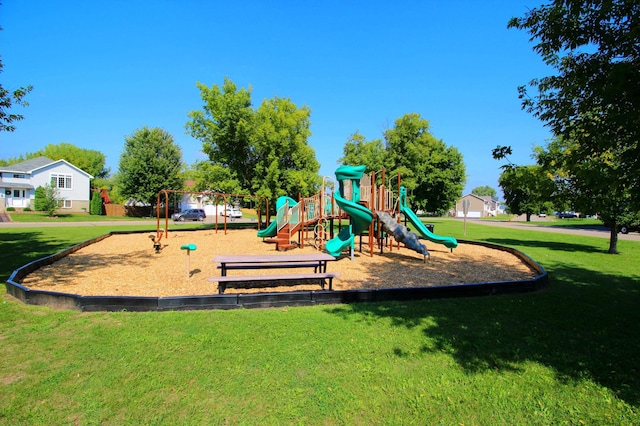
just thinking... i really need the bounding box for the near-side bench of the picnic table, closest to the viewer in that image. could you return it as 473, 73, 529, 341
209, 272, 340, 294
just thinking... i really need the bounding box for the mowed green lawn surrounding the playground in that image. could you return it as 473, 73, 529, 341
0, 219, 640, 425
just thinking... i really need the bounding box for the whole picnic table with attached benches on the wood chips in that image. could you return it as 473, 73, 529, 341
209, 253, 339, 294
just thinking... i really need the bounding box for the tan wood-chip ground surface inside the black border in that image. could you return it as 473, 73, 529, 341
22, 230, 537, 297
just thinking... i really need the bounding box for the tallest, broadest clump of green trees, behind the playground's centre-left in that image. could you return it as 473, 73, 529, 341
186, 79, 320, 208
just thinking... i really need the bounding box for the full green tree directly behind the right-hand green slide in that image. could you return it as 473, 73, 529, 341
384, 113, 466, 212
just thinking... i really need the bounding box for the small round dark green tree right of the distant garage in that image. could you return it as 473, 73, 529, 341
498, 165, 554, 222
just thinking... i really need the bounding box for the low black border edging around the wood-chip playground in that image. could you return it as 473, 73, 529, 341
6, 230, 549, 312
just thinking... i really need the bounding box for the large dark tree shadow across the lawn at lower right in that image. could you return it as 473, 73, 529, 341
329, 265, 640, 405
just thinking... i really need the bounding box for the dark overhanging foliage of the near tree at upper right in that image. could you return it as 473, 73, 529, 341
509, 0, 640, 210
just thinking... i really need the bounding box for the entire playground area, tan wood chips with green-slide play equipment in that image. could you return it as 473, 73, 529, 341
15, 166, 537, 297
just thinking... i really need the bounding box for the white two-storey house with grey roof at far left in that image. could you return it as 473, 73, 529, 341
0, 157, 93, 213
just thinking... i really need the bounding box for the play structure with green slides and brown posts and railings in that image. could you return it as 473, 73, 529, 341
258, 165, 458, 260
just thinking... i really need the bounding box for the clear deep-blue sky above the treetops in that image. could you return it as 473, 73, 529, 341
0, 0, 551, 193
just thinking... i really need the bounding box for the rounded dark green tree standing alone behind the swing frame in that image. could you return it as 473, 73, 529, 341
118, 127, 183, 206
